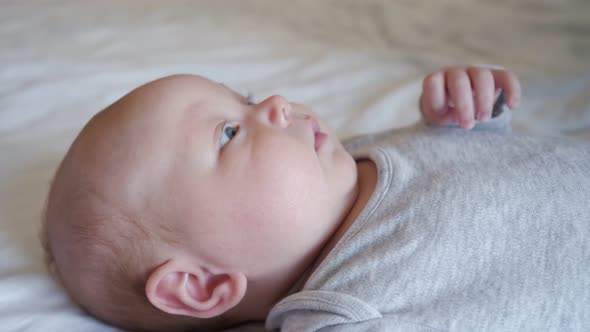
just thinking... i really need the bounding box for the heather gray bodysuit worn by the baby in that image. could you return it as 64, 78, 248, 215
266, 111, 590, 331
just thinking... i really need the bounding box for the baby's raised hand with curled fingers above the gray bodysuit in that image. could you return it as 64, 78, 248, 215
420, 67, 520, 129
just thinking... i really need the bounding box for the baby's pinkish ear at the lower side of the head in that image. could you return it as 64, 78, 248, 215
145, 260, 247, 318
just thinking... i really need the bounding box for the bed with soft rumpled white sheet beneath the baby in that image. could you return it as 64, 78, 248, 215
0, 0, 590, 332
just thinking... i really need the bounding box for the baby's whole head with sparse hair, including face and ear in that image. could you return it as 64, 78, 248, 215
43, 75, 357, 331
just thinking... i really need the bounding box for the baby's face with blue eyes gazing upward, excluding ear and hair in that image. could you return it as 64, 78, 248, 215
126, 76, 357, 275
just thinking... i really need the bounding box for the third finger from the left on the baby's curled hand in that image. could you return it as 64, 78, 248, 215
467, 67, 495, 122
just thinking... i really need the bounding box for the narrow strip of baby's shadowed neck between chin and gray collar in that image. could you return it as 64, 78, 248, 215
299, 159, 378, 288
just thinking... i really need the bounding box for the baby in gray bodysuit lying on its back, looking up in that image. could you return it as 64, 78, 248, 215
43, 67, 590, 331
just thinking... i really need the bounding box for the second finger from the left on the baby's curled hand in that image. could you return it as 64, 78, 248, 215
445, 68, 474, 129
